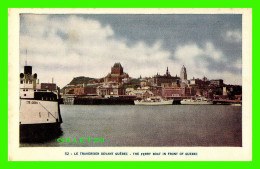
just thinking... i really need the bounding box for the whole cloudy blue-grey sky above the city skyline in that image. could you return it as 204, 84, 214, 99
19, 14, 242, 87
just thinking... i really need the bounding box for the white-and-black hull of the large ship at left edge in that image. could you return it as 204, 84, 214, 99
20, 99, 62, 142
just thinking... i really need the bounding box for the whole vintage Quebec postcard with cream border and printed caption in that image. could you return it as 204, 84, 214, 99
8, 8, 252, 161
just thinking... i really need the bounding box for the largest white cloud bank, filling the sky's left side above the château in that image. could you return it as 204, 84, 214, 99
20, 15, 171, 86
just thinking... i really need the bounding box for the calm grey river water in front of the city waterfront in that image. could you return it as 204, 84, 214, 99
20, 105, 242, 147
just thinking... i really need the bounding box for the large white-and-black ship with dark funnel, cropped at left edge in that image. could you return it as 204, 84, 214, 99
19, 65, 62, 142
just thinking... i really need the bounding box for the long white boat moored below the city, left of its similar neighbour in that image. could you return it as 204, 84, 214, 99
134, 97, 173, 105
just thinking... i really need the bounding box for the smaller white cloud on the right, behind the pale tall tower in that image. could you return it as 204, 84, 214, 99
173, 42, 242, 84
